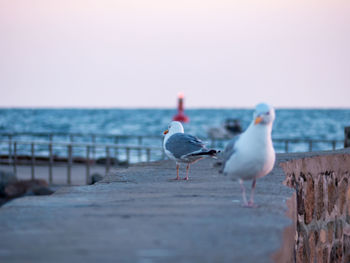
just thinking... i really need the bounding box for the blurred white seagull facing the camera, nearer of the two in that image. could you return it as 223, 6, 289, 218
222, 103, 276, 207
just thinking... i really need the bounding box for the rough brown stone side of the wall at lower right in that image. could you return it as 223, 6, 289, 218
281, 154, 350, 263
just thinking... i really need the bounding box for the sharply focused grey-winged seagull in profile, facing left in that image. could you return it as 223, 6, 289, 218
163, 121, 218, 180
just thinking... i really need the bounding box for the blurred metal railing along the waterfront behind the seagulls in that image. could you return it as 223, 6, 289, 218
0, 133, 344, 184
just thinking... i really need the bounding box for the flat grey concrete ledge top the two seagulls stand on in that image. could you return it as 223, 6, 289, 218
0, 150, 348, 262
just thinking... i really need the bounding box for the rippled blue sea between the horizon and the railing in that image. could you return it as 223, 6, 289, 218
0, 109, 350, 160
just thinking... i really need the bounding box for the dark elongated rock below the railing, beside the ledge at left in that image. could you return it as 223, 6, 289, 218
4, 179, 52, 199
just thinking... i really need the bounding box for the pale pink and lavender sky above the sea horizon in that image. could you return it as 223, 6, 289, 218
0, 0, 350, 108
